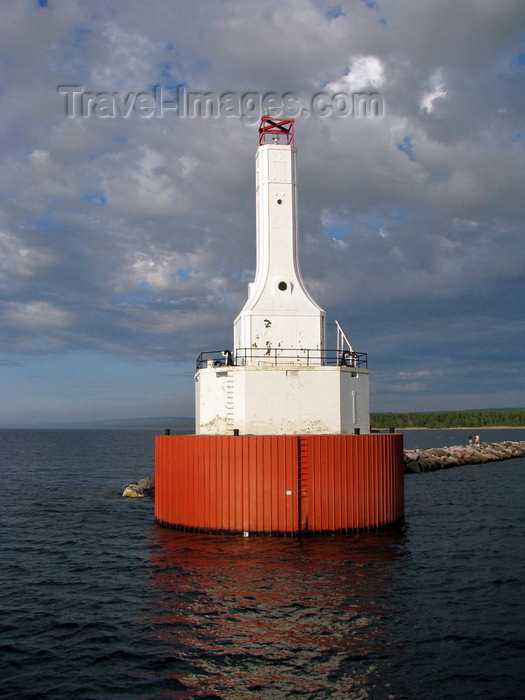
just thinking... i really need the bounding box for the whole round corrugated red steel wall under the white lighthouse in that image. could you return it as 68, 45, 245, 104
155, 435, 404, 535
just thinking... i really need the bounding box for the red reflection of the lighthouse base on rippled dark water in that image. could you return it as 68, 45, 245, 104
145, 528, 403, 698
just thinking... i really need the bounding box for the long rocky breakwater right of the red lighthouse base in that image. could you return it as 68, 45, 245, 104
404, 440, 525, 474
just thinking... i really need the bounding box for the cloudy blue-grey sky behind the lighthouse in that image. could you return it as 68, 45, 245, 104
0, 0, 525, 427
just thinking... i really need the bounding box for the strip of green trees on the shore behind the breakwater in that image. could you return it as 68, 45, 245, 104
370, 409, 525, 429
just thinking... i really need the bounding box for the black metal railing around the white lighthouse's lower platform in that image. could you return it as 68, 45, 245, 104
196, 348, 368, 370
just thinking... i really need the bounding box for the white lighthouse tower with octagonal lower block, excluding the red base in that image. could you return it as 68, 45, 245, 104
195, 117, 370, 435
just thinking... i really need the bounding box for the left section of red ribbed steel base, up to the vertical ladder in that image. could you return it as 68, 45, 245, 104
155, 435, 298, 534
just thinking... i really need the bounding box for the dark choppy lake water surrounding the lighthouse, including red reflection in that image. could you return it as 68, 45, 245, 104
0, 430, 525, 698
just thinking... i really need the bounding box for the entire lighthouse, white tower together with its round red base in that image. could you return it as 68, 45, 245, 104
155, 116, 404, 536
